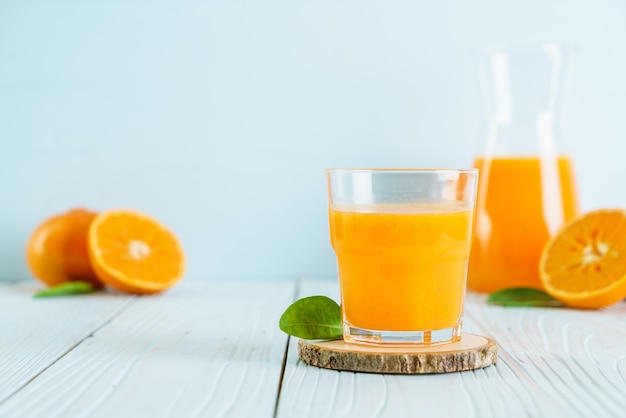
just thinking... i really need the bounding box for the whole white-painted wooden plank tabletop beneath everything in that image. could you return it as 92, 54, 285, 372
0, 280, 626, 418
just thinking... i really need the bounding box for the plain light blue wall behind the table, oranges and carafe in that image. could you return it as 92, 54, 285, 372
0, 0, 626, 280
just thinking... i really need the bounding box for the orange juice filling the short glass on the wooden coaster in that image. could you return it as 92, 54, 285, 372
329, 202, 472, 331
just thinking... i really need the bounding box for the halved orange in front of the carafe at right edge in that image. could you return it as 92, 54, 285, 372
539, 209, 626, 309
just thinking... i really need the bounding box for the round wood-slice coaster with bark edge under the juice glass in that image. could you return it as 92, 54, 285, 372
298, 334, 498, 374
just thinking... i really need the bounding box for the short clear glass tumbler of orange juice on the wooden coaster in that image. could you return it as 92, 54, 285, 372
326, 169, 478, 346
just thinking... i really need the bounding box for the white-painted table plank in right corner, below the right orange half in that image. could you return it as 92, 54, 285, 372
460, 295, 626, 417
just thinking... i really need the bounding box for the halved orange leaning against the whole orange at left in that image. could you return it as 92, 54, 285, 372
89, 209, 185, 294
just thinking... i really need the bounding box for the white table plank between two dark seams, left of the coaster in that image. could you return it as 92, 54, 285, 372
0, 281, 294, 418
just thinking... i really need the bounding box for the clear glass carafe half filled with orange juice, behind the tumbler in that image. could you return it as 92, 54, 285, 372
468, 45, 578, 292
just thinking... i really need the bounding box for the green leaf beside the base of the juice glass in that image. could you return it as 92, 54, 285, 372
278, 296, 343, 340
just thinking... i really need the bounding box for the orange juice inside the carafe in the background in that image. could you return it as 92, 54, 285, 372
467, 156, 578, 292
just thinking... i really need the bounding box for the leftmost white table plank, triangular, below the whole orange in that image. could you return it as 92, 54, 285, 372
0, 281, 132, 404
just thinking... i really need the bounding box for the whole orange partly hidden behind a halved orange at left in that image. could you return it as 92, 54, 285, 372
26, 209, 102, 286
